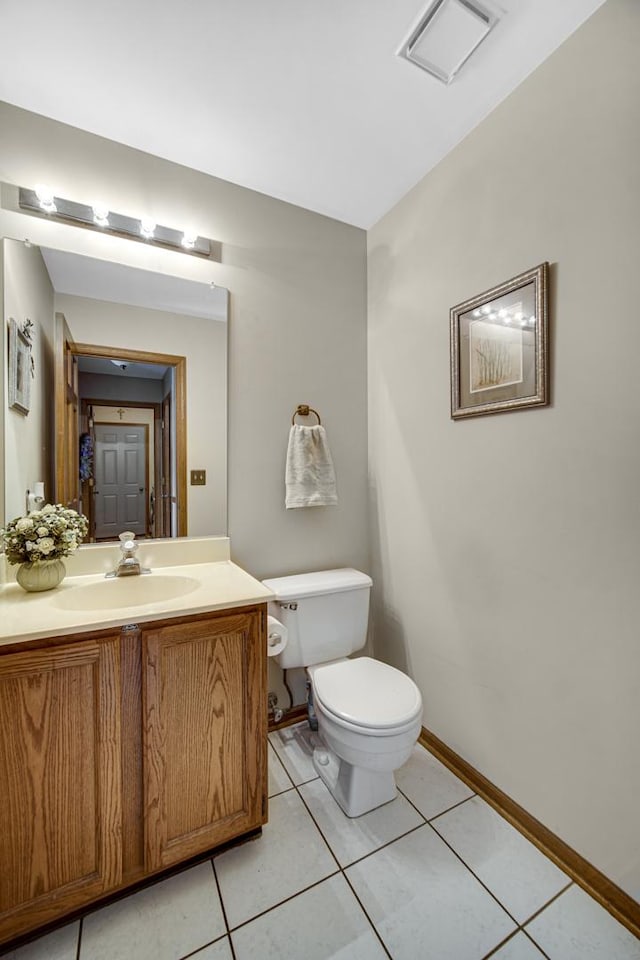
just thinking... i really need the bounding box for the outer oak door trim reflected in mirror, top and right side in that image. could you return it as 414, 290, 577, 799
70, 342, 187, 537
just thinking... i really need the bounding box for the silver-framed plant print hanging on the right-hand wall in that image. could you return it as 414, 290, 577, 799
450, 263, 549, 420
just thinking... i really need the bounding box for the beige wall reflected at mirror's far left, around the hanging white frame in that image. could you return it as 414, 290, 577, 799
0, 240, 53, 520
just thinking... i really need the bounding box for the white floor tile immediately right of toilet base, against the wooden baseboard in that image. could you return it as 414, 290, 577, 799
396, 744, 473, 820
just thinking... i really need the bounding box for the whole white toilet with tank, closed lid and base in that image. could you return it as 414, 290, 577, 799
263, 568, 422, 817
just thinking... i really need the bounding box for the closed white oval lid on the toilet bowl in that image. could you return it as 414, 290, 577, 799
313, 657, 422, 728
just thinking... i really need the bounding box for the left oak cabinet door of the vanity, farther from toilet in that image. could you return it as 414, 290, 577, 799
0, 638, 121, 940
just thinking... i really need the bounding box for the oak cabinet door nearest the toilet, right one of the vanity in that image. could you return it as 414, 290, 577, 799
143, 609, 266, 870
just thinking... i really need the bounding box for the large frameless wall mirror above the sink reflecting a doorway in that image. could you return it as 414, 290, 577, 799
3, 238, 228, 539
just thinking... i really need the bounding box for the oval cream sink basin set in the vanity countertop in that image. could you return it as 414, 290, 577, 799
52, 573, 200, 611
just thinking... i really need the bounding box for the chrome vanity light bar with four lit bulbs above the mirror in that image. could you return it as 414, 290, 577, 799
18, 185, 222, 262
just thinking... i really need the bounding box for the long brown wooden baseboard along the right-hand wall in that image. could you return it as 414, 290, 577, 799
419, 727, 640, 937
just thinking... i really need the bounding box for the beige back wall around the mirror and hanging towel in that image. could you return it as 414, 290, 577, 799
0, 104, 368, 577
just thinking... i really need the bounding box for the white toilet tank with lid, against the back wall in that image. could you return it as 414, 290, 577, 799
263, 568, 372, 670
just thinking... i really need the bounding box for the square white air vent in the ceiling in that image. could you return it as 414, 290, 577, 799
398, 0, 499, 83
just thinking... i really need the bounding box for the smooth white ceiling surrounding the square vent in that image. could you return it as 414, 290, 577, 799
0, 0, 603, 228
